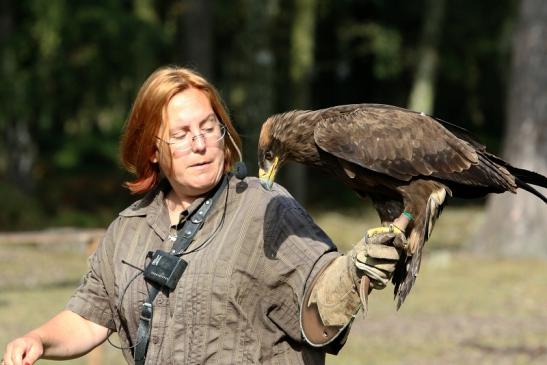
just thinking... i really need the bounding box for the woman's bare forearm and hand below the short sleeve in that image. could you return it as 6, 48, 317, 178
3, 310, 108, 365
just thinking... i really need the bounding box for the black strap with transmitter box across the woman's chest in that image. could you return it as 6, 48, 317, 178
133, 176, 228, 365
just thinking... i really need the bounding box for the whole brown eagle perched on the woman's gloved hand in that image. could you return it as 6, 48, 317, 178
258, 104, 547, 309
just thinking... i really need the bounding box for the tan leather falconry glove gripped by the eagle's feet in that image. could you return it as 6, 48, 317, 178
301, 230, 401, 346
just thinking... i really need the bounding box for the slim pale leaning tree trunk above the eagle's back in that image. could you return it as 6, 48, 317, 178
408, 0, 445, 114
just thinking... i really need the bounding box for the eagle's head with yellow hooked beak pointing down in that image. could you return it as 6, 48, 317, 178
258, 115, 287, 190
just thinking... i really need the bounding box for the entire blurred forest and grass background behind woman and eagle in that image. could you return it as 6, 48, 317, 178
0, 0, 547, 365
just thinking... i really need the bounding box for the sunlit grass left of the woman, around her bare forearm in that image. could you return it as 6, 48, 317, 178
0, 245, 125, 365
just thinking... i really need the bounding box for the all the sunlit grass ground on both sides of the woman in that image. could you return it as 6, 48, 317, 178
0, 207, 547, 365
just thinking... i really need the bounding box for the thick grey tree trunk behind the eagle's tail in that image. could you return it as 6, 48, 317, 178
474, 0, 547, 257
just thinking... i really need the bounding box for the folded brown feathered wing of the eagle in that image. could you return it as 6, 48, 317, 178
314, 104, 479, 181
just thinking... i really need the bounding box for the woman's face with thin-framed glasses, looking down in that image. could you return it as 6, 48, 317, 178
154, 88, 224, 199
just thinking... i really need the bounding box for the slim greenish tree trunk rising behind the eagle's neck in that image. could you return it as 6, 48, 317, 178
286, 0, 316, 205
